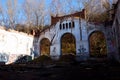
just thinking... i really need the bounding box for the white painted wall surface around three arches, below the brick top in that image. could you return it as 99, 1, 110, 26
37, 18, 112, 60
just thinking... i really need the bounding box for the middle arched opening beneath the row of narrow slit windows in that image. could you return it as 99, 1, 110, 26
61, 33, 76, 55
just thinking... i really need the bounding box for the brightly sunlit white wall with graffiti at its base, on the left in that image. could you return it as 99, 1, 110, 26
0, 28, 33, 64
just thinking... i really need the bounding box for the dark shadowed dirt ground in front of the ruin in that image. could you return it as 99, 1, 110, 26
0, 61, 120, 80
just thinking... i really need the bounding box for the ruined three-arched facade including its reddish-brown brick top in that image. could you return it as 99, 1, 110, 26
34, 10, 115, 60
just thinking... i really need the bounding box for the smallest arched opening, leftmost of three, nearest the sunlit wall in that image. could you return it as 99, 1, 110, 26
40, 38, 50, 56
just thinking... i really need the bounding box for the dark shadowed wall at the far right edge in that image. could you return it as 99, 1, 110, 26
112, 0, 120, 59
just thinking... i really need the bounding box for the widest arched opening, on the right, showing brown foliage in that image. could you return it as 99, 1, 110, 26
89, 31, 107, 58
